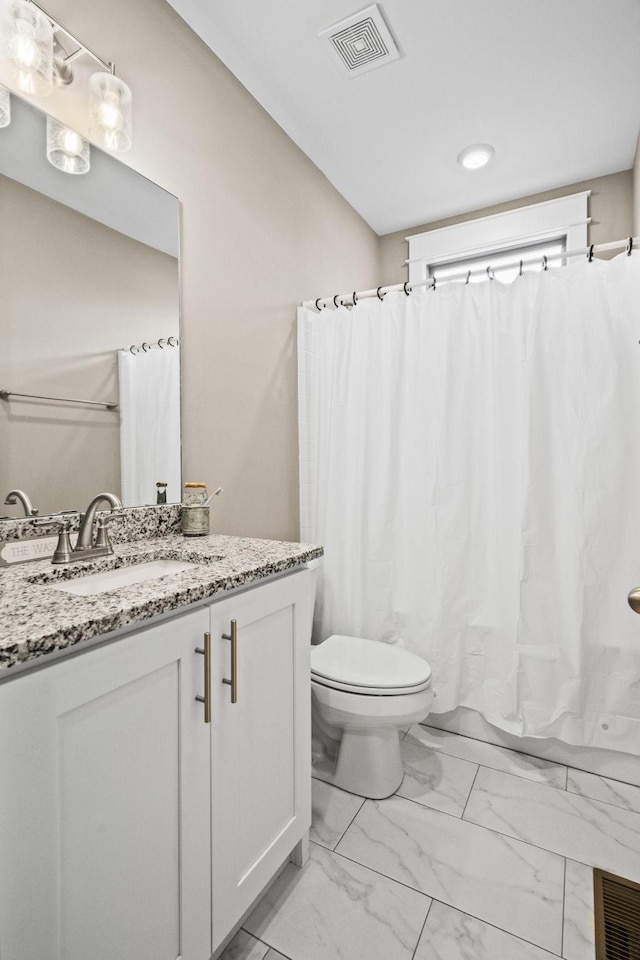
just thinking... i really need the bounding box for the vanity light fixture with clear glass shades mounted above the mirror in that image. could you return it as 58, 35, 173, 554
0, 0, 132, 152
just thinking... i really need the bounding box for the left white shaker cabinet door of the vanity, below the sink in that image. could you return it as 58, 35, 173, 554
0, 608, 211, 960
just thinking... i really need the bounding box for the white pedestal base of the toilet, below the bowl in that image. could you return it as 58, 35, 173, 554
313, 727, 404, 800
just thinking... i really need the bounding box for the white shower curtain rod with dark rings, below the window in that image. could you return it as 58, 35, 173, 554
302, 237, 640, 310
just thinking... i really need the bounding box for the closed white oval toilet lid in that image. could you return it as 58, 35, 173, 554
311, 634, 431, 694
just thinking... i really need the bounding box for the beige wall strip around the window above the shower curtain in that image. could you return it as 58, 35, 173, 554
380, 170, 640, 284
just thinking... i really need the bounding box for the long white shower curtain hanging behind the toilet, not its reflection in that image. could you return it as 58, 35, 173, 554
298, 255, 640, 753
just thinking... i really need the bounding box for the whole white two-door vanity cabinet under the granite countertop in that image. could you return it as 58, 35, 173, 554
0, 569, 313, 960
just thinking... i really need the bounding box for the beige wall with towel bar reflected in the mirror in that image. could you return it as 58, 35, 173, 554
0, 177, 179, 516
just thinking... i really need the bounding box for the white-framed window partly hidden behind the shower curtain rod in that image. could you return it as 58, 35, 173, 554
407, 191, 589, 283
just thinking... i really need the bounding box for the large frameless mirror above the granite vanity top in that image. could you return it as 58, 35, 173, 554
0, 94, 180, 518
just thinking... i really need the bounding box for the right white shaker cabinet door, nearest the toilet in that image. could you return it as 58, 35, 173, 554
211, 570, 313, 950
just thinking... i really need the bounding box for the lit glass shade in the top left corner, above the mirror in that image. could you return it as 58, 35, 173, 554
2, 0, 53, 97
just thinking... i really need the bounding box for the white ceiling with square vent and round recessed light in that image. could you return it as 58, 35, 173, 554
164, 0, 640, 234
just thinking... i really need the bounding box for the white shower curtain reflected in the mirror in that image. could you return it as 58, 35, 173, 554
118, 347, 181, 507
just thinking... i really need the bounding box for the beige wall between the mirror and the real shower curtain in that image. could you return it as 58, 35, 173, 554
32, 0, 379, 539
